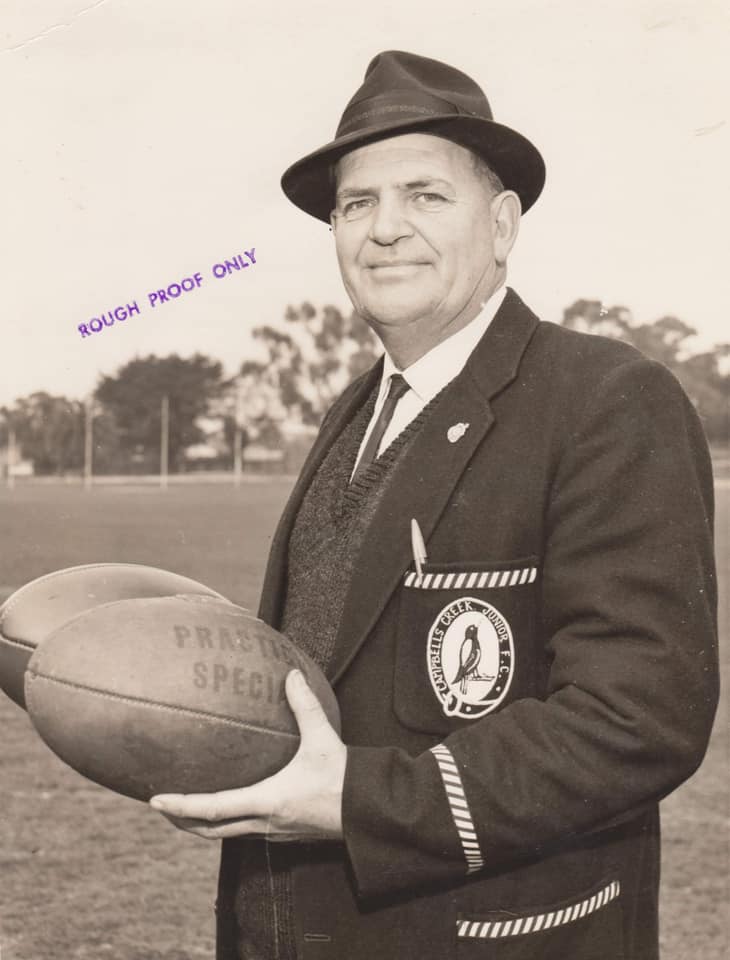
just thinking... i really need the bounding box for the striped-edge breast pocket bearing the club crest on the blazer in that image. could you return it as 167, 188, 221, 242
393, 557, 539, 736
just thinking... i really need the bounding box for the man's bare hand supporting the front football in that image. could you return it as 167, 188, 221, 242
150, 670, 347, 841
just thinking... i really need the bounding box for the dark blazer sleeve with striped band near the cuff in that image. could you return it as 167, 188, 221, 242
343, 359, 718, 897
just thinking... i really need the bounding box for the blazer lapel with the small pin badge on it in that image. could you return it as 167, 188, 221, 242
327, 290, 538, 683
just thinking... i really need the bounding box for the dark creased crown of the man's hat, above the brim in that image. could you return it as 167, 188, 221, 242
335, 50, 493, 137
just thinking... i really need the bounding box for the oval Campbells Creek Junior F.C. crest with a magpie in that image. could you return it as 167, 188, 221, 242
427, 597, 515, 720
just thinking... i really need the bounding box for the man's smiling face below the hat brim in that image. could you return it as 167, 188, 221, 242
333, 133, 503, 349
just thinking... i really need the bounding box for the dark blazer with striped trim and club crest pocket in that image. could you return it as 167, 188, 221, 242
220, 290, 717, 960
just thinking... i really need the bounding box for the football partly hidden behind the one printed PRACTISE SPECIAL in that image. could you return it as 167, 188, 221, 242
0, 563, 223, 707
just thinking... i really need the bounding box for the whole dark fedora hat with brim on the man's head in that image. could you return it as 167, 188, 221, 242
281, 50, 545, 223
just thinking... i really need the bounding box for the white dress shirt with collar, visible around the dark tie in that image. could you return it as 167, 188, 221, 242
352, 286, 507, 476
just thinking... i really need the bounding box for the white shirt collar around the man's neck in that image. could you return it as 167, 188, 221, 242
380, 286, 507, 404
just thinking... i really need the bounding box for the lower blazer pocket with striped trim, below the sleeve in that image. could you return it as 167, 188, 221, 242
456, 880, 624, 960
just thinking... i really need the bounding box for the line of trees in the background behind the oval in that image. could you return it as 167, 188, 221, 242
0, 300, 730, 475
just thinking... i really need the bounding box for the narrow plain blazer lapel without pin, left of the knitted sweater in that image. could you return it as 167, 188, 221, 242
258, 359, 383, 627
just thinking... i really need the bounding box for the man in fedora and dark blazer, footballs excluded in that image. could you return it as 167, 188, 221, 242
153, 52, 717, 960
